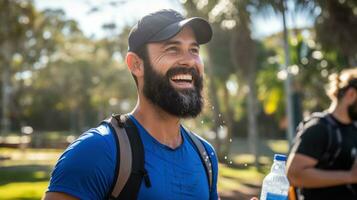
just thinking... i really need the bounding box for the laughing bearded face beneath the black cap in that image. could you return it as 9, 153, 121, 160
143, 28, 203, 117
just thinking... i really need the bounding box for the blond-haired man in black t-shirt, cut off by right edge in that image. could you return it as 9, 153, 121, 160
287, 68, 357, 200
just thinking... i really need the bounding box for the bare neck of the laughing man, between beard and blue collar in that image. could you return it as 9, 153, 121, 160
132, 99, 182, 149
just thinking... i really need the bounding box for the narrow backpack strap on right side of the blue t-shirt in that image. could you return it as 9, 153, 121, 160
182, 126, 213, 192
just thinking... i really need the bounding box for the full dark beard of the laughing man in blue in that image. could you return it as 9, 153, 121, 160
143, 59, 203, 118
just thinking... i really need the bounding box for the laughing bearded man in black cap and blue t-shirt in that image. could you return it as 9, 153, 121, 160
45, 10, 218, 200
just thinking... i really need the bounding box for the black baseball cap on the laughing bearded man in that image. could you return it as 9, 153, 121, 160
128, 9, 212, 52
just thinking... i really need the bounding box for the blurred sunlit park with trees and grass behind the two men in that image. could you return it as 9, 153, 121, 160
0, 0, 357, 199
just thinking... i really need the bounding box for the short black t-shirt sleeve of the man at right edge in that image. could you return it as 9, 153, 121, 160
292, 123, 328, 160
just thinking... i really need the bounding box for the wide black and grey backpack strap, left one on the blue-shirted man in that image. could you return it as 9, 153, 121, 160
103, 115, 151, 200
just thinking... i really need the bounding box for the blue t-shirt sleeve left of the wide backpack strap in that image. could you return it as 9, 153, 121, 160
48, 126, 116, 199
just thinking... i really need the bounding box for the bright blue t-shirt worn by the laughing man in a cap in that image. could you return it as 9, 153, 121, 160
48, 116, 218, 200
